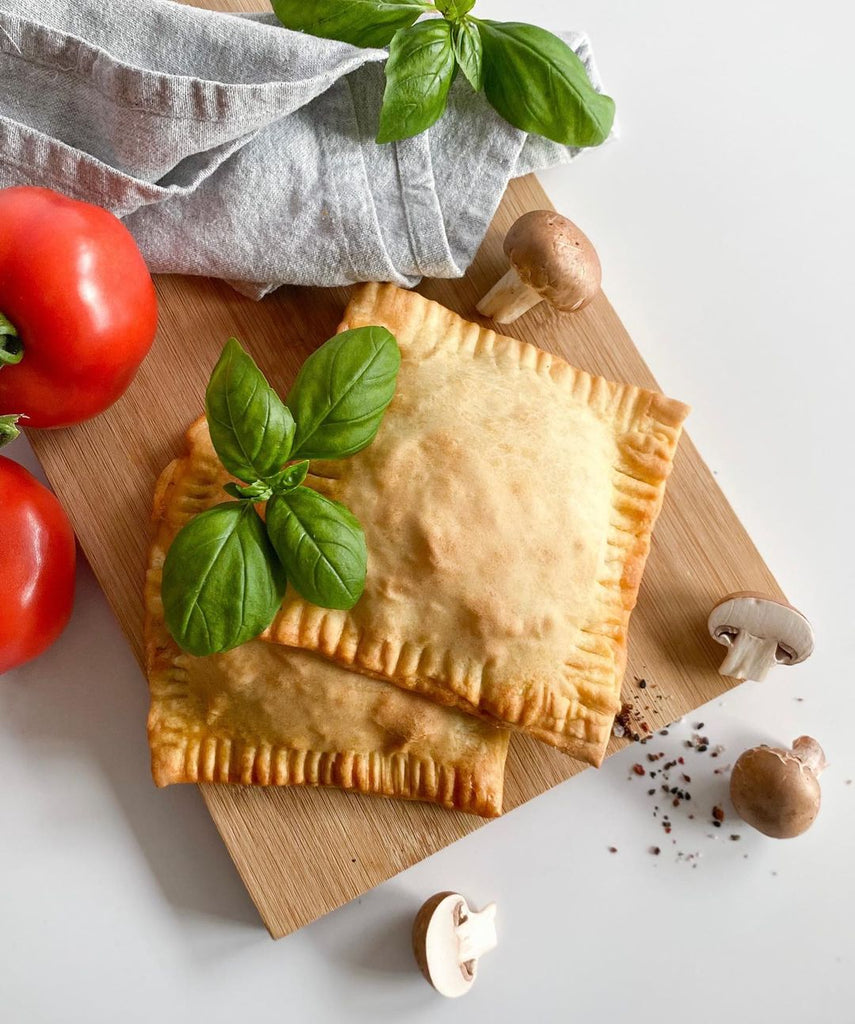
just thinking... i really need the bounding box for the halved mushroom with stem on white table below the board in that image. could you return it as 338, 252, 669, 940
413, 893, 498, 998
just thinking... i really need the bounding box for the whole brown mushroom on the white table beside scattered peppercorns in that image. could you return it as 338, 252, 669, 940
730, 736, 826, 839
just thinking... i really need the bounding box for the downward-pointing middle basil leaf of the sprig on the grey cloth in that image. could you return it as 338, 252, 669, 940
377, 18, 456, 142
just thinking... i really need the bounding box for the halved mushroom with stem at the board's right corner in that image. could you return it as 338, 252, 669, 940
708, 591, 813, 680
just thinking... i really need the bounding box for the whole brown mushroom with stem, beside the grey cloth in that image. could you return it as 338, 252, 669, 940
477, 210, 602, 324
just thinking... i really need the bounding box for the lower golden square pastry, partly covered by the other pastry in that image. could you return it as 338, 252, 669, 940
145, 420, 508, 816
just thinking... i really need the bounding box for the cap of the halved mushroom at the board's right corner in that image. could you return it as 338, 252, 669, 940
708, 590, 814, 665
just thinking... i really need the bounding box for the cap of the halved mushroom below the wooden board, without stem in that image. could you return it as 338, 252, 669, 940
413, 892, 477, 998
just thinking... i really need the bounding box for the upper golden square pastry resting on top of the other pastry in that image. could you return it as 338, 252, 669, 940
267, 285, 688, 765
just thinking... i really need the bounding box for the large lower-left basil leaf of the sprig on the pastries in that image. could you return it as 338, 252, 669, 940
161, 502, 286, 656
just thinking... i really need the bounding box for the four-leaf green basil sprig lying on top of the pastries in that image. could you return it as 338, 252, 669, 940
162, 327, 400, 656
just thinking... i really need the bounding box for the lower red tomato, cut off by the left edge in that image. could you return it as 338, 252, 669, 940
0, 456, 75, 672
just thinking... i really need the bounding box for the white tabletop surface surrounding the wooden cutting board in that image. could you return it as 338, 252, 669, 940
0, 0, 855, 1024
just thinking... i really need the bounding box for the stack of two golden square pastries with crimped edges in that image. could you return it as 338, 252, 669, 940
146, 285, 687, 816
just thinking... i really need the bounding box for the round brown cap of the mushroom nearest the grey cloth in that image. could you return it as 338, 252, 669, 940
504, 210, 602, 312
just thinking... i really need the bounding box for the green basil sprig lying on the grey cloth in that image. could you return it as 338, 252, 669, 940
272, 0, 614, 146
